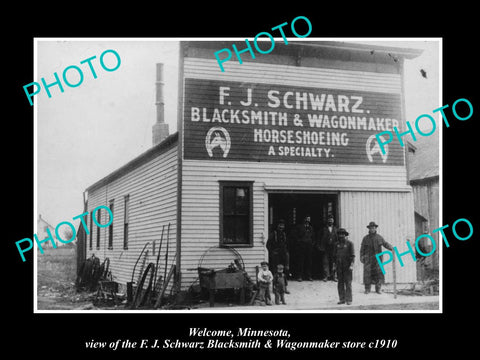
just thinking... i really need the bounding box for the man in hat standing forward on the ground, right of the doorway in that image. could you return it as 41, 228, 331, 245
333, 228, 355, 305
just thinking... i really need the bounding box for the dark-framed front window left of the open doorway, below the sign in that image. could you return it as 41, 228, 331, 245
220, 181, 253, 246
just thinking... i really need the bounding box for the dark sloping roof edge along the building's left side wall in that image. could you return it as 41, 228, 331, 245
86, 132, 178, 192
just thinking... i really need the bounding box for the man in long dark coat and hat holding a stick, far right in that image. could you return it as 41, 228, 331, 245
360, 221, 393, 294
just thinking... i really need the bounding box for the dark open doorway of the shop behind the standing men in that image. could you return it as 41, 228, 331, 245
268, 192, 339, 279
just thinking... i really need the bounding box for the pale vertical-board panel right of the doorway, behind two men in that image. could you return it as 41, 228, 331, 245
339, 191, 416, 283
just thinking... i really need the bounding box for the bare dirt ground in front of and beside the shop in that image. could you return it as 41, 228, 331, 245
37, 246, 439, 311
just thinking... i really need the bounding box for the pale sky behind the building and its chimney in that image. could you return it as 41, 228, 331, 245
35, 38, 442, 229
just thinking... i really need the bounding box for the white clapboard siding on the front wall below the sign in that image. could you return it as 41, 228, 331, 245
181, 160, 413, 286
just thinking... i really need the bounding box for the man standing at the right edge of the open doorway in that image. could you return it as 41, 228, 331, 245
317, 215, 337, 281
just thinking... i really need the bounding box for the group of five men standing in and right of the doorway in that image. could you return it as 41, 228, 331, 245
266, 215, 393, 304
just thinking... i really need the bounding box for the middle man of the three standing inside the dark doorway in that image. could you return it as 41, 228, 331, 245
296, 216, 315, 281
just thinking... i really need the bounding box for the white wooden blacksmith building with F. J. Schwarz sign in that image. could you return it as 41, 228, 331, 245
79, 41, 419, 296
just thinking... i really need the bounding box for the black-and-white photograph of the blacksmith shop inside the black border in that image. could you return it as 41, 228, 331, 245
31, 38, 442, 312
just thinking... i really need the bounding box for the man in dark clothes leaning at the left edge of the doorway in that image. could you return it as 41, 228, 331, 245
266, 220, 290, 294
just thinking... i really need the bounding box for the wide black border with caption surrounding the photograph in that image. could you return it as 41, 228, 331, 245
6, 2, 480, 359
